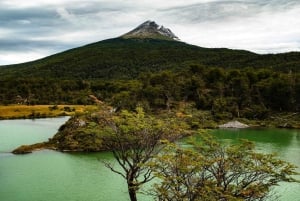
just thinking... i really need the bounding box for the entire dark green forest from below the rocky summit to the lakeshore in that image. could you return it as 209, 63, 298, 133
0, 38, 300, 119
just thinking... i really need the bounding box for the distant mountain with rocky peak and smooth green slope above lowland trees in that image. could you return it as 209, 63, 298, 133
0, 21, 300, 79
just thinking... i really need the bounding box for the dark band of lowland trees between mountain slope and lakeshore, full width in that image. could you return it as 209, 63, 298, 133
0, 64, 300, 119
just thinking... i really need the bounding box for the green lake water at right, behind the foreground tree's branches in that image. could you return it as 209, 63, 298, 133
212, 129, 300, 201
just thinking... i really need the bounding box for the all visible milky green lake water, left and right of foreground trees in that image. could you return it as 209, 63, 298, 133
0, 118, 300, 201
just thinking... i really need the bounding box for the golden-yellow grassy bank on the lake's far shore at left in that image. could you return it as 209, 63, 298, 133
0, 105, 97, 119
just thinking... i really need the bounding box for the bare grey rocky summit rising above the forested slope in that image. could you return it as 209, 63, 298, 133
121, 20, 179, 40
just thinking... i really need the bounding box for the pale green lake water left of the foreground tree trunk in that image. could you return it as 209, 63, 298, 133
0, 118, 136, 201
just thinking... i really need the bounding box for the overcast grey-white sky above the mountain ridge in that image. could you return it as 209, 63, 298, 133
0, 0, 300, 65
